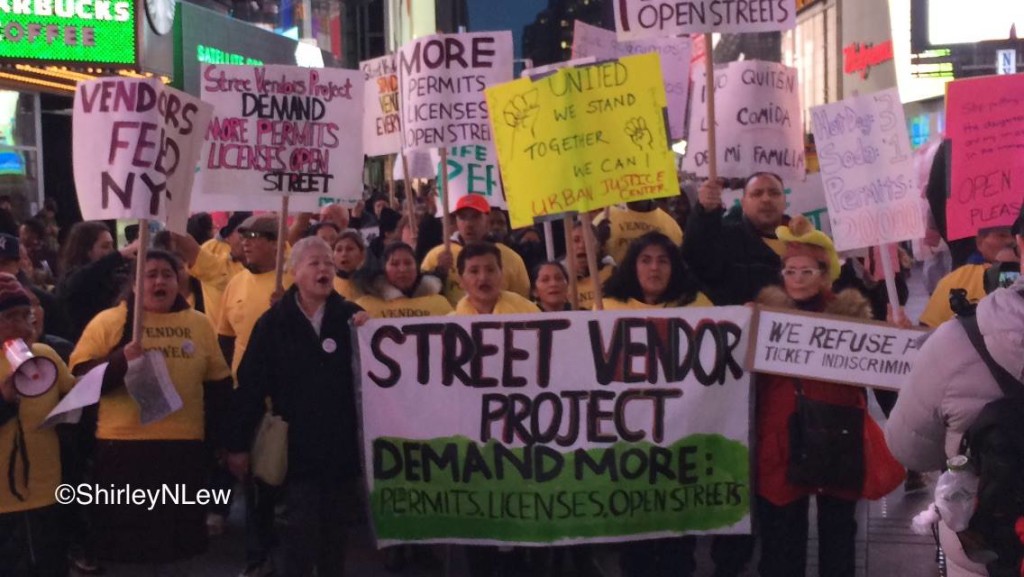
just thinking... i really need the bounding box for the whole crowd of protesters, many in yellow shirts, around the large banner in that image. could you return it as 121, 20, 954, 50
0, 168, 1024, 577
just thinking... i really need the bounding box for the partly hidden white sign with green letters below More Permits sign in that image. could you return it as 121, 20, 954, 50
430, 145, 508, 210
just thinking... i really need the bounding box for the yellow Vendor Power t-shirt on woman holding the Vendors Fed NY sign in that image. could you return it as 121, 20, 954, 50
71, 303, 231, 441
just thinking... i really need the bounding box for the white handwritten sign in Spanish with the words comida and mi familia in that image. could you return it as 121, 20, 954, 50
683, 60, 807, 181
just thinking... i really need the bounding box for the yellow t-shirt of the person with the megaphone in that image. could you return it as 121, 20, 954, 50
0, 346, 75, 514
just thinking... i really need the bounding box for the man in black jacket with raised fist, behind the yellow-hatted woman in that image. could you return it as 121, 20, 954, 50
683, 172, 788, 307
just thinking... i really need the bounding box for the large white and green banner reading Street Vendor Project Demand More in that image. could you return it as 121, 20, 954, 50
358, 306, 753, 546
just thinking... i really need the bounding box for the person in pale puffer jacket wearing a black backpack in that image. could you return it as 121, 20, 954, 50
886, 214, 1024, 577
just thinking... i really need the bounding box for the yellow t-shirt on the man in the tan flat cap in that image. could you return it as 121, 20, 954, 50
217, 271, 292, 374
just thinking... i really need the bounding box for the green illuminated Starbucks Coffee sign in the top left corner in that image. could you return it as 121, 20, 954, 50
0, 0, 135, 65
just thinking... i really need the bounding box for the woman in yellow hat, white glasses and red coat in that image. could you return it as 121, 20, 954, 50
754, 216, 903, 577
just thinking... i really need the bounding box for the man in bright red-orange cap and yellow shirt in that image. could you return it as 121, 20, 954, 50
420, 195, 529, 306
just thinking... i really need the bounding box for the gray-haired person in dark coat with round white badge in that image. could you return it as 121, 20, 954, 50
227, 237, 366, 576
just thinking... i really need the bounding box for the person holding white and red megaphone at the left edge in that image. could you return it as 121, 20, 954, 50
0, 273, 75, 575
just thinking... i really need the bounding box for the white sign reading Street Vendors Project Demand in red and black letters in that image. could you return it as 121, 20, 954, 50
197, 65, 364, 204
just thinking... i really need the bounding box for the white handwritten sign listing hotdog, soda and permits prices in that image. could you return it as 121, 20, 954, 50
811, 88, 925, 250
